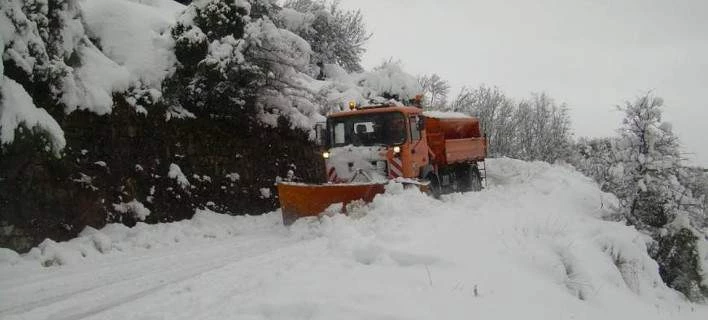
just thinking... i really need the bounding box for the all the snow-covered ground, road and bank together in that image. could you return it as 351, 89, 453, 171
0, 159, 708, 320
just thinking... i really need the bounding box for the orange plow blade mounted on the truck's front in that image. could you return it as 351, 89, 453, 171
278, 182, 386, 225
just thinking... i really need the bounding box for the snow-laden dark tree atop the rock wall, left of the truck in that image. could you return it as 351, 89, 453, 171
168, 0, 320, 130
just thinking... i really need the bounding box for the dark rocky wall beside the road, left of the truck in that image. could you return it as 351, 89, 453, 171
0, 97, 324, 251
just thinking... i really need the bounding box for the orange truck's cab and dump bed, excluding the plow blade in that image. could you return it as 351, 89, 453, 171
323, 106, 487, 191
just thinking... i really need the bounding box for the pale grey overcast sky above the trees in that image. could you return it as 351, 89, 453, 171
342, 0, 708, 166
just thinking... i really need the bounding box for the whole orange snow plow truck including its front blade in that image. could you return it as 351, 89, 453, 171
277, 103, 487, 225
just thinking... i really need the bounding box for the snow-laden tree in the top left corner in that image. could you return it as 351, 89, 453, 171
0, 0, 83, 154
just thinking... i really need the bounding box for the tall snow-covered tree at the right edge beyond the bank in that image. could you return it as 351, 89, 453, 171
610, 94, 708, 300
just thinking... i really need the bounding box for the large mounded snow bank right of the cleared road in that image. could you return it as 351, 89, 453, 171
265, 159, 705, 319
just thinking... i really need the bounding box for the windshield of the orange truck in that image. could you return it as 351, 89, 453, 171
327, 112, 406, 147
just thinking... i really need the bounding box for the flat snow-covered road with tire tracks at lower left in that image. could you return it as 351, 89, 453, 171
0, 238, 294, 320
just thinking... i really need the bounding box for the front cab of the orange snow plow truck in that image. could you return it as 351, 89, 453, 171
323, 106, 430, 183
